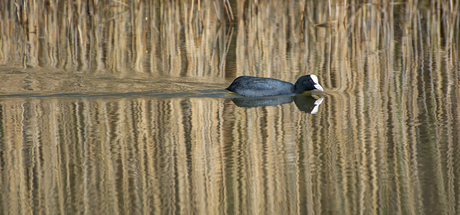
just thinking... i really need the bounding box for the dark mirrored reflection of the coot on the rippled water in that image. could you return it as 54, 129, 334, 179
232, 95, 323, 114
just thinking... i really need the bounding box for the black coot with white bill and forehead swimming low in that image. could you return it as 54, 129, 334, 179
227, 75, 323, 97
